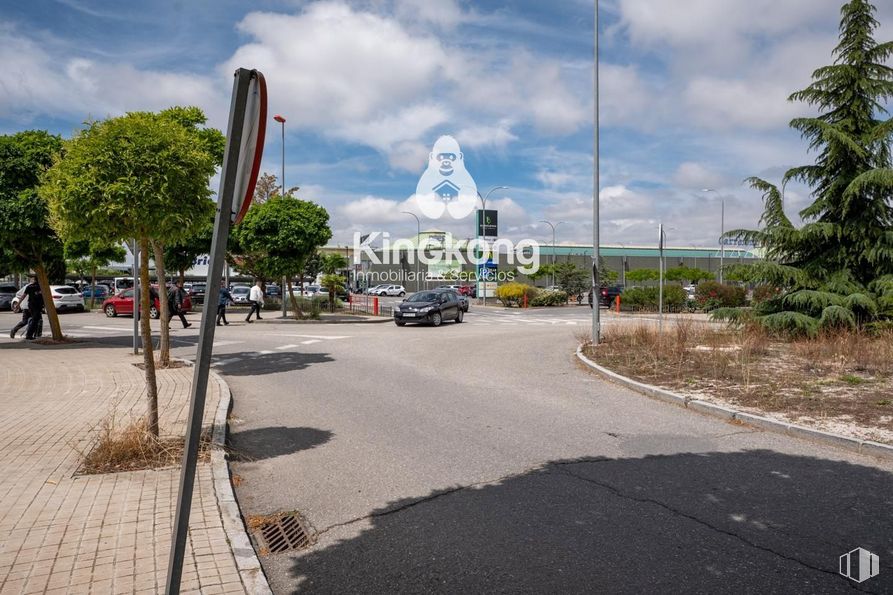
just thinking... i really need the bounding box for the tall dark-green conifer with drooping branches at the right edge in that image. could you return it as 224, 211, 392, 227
715, 0, 893, 334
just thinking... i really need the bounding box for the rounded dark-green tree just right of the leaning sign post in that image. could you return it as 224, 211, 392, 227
233, 195, 332, 317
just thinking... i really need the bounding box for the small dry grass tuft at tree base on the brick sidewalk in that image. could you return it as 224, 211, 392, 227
78, 411, 210, 475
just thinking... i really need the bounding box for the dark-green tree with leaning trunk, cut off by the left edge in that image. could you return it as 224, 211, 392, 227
0, 130, 65, 341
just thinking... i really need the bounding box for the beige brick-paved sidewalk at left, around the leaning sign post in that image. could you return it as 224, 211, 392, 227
0, 341, 266, 595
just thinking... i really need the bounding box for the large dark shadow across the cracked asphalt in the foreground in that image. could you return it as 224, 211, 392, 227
284, 450, 893, 593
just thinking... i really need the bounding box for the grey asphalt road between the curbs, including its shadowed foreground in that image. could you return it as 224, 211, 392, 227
0, 306, 893, 593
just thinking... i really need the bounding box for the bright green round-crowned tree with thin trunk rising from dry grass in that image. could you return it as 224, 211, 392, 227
40, 112, 214, 437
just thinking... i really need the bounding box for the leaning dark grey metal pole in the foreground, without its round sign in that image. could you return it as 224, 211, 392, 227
165, 68, 252, 595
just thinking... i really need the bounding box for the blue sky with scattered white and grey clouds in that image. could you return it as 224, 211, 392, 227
0, 0, 893, 246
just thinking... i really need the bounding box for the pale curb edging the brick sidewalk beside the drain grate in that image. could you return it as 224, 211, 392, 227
210, 370, 273, 595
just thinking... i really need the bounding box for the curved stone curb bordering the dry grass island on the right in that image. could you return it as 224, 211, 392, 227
577, 345, 893, 460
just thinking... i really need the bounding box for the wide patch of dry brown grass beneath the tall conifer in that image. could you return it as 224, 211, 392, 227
586, 320, 893, 442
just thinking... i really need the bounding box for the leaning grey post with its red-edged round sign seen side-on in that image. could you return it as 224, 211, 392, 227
166, 68, 267, 595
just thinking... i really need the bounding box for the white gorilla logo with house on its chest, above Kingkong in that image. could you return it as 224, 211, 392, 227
415, 136, 477, 219
